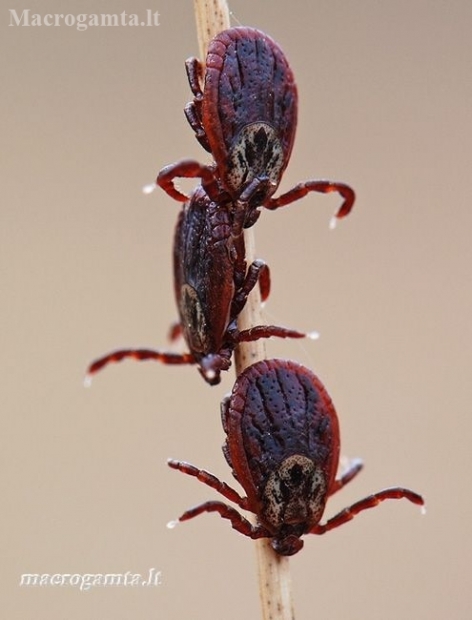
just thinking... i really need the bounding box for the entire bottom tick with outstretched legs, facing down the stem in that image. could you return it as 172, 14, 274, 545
169, 359, 424, 555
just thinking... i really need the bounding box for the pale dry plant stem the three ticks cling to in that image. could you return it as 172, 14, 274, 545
194, 0, 295, 620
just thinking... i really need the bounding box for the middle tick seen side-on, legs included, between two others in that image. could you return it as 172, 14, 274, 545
88, 186, 307, 385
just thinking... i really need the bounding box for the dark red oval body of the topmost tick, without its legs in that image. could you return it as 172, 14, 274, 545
195, 28, 298, 200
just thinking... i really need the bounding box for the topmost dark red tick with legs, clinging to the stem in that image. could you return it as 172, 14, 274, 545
157, 27, 355, 232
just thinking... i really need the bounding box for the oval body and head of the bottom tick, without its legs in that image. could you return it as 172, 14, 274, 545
222, 360, 340, 551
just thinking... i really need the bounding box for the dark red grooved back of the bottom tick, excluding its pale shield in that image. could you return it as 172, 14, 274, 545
224, 360, 339, 512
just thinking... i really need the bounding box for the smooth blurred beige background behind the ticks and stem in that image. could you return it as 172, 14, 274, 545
0, 0, 472, 620
